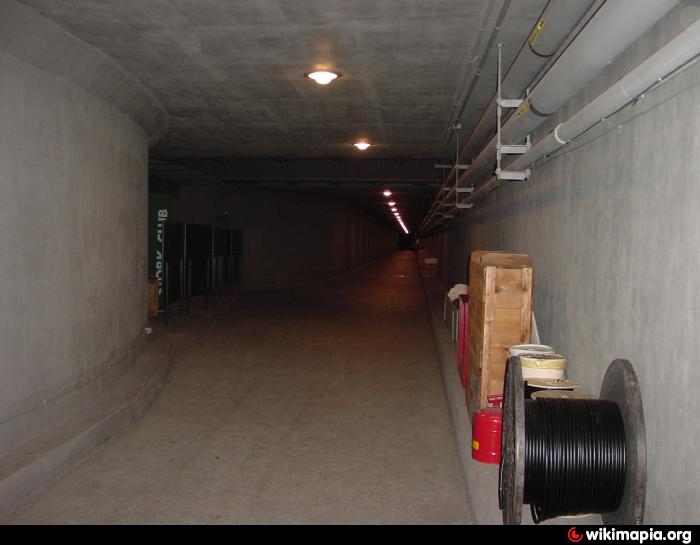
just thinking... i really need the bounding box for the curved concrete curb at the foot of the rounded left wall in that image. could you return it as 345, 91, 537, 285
0, 340, 170, 519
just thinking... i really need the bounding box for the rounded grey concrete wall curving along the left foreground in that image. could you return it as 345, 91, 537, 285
0, 1, 163, 450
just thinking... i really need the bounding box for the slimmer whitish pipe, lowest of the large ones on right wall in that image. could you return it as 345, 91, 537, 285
464, 16, 700, 208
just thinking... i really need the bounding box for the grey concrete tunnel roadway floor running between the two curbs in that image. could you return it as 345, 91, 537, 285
7, 253, 472, 523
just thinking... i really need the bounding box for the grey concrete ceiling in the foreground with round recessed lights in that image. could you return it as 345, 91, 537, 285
21, 0, 546, 159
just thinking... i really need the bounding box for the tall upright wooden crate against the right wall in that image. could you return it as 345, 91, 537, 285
466, 251, 533, 414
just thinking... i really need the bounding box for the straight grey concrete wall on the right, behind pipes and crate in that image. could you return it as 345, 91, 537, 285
427, 2, 700, 524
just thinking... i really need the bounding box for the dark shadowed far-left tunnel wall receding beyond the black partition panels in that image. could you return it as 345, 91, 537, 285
171, 186, 397, 286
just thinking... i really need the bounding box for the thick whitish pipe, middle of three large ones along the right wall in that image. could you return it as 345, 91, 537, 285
423, 0, 678, 229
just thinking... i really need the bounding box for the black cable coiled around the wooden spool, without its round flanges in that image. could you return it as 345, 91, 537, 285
523, 398, 625, 523
